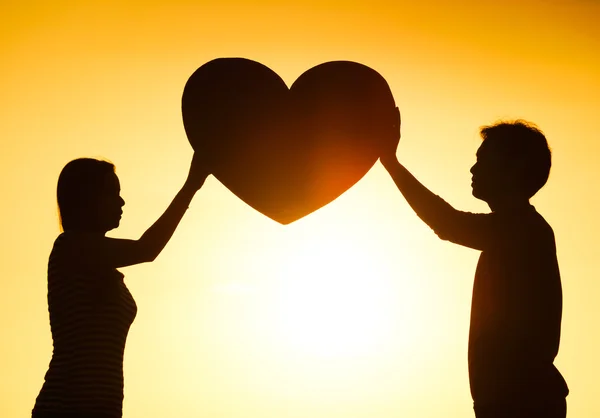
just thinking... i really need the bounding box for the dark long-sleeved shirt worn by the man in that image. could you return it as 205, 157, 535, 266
430, 199, 569, 406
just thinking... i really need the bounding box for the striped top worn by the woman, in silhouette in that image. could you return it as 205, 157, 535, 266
33, 232, 137, 418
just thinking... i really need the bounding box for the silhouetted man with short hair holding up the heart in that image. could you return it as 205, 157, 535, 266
381, 112, 569, 418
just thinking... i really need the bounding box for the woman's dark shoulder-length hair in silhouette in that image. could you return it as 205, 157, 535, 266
56, 158, 115, 231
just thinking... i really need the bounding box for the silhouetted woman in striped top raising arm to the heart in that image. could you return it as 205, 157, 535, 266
32, 153, 209, 418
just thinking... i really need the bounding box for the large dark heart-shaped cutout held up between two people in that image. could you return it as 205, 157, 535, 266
182, 58, 395, 225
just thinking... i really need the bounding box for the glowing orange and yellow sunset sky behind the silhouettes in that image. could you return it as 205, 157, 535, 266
0, 0, 600, 418
